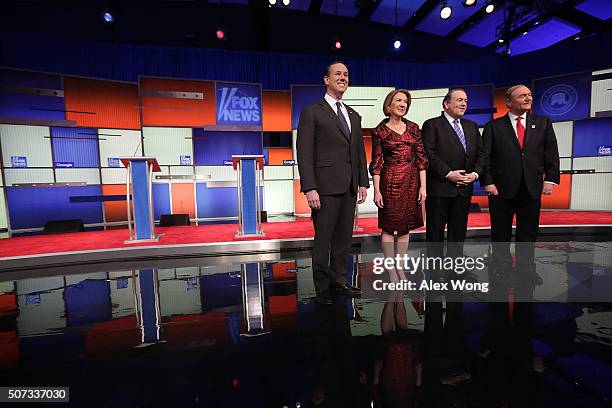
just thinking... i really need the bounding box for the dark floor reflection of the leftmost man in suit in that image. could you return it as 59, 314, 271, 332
311, 302, 358, 408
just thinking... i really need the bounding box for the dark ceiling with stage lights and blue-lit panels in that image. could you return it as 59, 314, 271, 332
0, 0, 612, 62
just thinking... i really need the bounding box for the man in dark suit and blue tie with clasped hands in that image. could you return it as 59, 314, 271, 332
421, 88, 484, 262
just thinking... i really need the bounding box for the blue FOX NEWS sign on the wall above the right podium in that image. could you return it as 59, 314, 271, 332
217, 85, 261, 125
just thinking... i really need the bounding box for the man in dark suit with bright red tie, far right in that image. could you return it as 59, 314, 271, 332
482, 85, 560, 280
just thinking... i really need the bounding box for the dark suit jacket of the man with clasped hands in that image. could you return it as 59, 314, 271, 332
421, 114, 485, 197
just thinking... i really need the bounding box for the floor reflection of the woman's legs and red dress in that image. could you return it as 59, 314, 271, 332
373, 291, 422, 408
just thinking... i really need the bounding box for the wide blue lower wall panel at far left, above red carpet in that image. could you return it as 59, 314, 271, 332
6, 185, 102, 229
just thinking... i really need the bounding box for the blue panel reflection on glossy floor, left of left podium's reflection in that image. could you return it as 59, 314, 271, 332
64, 279, 112, 326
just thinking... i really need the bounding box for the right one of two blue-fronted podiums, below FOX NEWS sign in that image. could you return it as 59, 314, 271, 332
232, 155, 264, 237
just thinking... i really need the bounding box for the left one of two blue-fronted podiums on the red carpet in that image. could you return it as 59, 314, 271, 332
119, 157, 161, 244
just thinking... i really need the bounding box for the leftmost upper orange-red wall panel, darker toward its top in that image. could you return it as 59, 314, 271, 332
64, 76, 140, 129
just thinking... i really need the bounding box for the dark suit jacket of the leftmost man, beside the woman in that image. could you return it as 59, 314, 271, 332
297, 99, 369, 195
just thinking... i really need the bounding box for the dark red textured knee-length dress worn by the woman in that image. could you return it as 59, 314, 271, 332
370, 119, 429, 236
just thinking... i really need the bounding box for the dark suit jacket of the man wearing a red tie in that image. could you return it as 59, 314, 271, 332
481, 114, 560, 199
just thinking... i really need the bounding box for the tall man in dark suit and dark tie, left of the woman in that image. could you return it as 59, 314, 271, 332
297, 61, 369, 304
